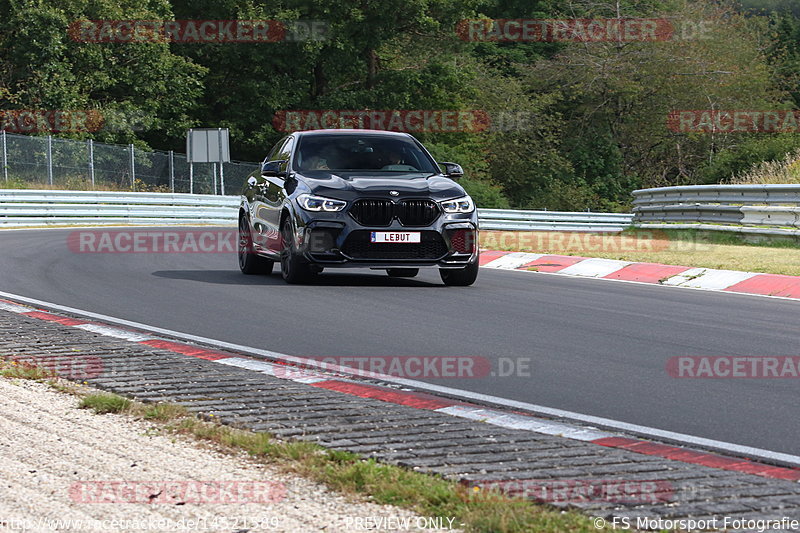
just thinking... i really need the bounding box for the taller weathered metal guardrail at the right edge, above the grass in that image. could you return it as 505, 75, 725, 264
633, 185, 800, 235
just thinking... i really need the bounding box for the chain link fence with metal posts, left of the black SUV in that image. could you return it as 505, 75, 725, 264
0, 131, 258, 194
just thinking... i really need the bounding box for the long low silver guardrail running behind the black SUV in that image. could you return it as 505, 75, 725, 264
0, 189, 633, 232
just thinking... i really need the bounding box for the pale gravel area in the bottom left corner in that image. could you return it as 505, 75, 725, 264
0, 378, 456, 533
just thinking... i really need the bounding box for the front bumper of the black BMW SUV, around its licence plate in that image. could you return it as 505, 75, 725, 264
296, 205, 478, 268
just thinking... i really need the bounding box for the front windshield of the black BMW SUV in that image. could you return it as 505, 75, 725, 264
294, 134, 438, 173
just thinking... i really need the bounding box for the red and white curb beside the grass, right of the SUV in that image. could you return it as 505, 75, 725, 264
481, 251, 800, 299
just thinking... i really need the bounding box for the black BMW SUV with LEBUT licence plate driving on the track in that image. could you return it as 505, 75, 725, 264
238, 130, 478, 286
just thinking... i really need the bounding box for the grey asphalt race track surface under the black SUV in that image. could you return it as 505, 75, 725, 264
0, 229, 800, 455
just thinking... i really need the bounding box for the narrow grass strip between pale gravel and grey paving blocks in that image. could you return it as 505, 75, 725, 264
0, 360, 610, 533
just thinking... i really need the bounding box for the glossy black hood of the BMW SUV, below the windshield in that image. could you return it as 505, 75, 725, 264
298, 171, 466, 200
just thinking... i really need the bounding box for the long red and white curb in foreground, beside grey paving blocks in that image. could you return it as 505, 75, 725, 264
0, 294, 800, 482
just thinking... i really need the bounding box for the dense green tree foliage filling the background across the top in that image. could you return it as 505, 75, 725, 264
0, 0, 800, 210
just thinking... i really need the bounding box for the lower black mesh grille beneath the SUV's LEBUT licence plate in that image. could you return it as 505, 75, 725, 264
342, 230, 447, 260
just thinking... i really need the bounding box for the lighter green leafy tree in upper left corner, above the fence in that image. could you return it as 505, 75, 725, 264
0, 0, 204, 145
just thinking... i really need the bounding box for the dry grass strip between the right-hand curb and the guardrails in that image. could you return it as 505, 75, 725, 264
480, 229, 800, 276
